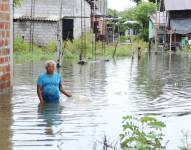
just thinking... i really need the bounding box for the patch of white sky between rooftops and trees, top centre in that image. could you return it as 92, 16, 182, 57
108, 0, 135, 11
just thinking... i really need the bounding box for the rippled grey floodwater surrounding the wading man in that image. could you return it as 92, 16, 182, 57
0, 53, 191, 150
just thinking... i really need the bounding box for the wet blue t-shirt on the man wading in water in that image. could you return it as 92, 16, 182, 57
37, 73, 62, 102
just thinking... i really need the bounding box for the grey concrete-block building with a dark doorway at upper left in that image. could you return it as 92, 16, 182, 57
14, 0, 91, 46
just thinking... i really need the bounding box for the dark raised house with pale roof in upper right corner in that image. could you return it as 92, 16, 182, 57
164, 0, 191, 46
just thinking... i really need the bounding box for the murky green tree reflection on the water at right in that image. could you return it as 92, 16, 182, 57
136, 54, 165, 100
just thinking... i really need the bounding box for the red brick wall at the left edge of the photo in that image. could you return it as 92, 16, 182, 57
0, 0, 11, 94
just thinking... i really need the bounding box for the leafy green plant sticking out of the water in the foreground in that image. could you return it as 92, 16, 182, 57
120, 116, 165, 150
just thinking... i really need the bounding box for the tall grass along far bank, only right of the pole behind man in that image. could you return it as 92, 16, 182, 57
63, 34, 148, 59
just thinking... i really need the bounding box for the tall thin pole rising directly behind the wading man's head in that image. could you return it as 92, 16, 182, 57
57, 0, 63, 67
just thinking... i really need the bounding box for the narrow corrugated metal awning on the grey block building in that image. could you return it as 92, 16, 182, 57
14, 15, 59, 21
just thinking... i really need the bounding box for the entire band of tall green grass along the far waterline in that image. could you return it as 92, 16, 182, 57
14, 34, 147, 63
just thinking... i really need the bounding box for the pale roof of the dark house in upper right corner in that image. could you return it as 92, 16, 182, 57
164, 0, 191, 11
